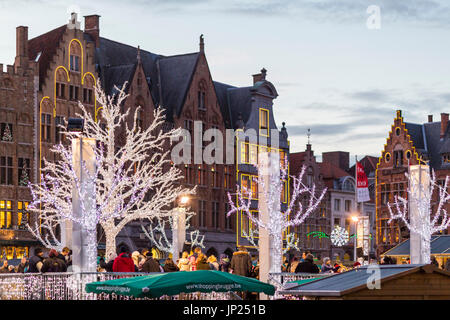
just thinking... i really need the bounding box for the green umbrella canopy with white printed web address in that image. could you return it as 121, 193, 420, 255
86, 270, 275, 298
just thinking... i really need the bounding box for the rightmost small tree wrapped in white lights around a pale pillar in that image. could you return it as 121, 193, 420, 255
388, 165, 450, 264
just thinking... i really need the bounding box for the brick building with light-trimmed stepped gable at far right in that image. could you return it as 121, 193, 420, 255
376, 110, 450, 254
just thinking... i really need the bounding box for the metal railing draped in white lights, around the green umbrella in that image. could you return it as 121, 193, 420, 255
0, 272, 241, 300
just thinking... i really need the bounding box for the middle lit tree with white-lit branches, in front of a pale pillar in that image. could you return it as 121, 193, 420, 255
228, 158, 326, 273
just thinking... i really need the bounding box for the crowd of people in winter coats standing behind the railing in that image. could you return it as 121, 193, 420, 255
0, 246, 450, 278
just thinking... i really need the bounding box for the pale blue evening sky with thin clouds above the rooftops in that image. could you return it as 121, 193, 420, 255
0, 0, 450, 162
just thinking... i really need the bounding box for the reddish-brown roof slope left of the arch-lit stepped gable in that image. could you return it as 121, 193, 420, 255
28, 25, 67, 85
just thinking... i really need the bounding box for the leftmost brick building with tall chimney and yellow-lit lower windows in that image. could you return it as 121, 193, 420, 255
0, 26, 37, 259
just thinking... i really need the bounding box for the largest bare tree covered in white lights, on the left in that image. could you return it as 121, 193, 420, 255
29, 83, 195, 258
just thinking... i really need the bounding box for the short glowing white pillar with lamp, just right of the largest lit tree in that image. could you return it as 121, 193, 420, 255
172, 195, 189, 262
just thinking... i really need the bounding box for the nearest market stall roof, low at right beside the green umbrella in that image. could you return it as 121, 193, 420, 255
281, 264, 450, 296
